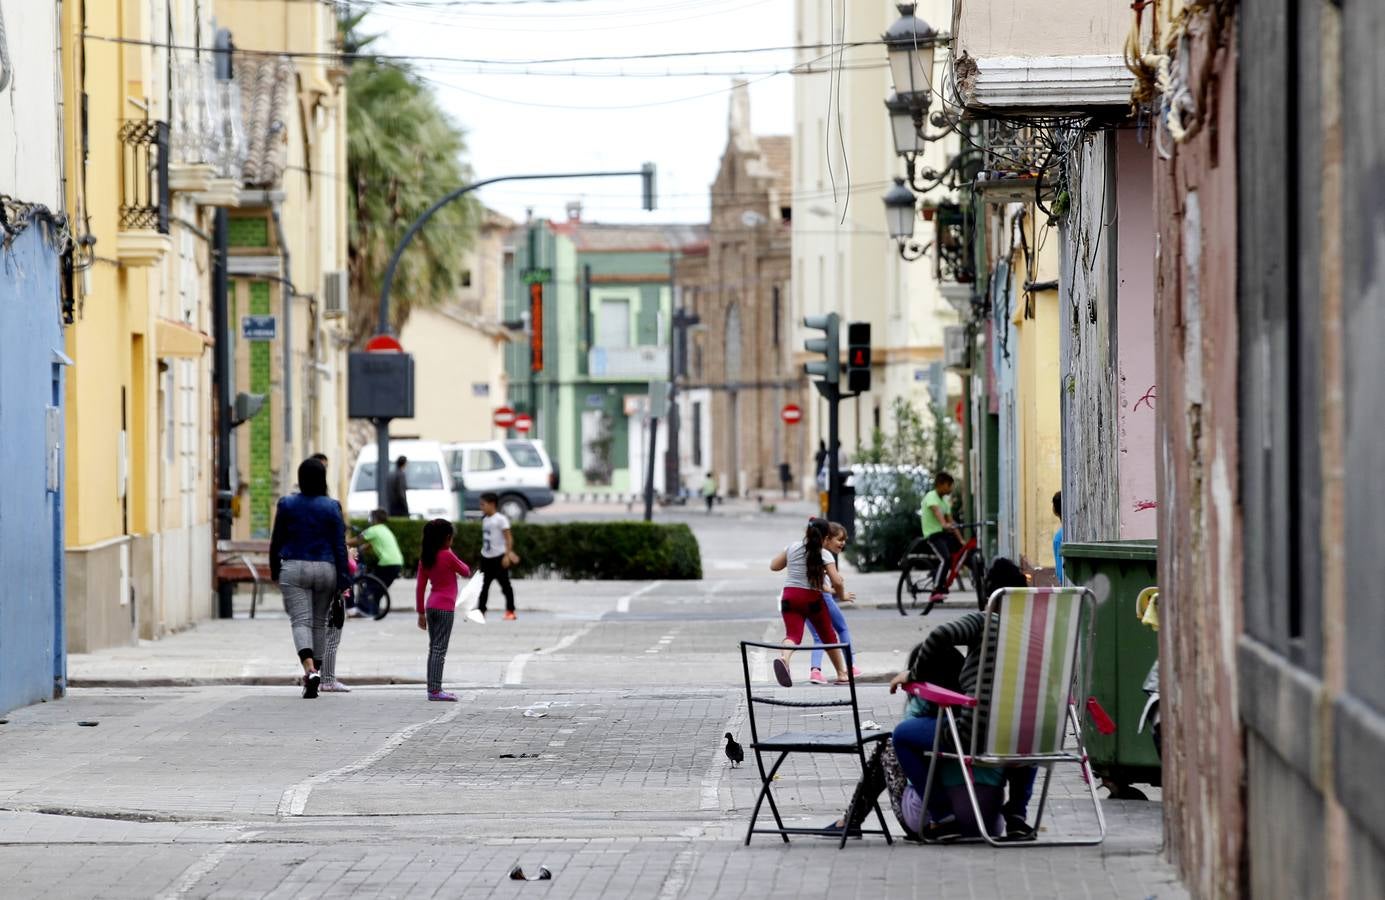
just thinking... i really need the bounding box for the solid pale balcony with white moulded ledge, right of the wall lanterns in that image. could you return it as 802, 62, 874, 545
951, 0, 1134, 114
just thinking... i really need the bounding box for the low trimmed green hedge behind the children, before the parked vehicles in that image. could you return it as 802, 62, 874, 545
353, 519, 702, 582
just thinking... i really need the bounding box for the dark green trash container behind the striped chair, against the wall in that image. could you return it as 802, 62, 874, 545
1062, 540, 1161, 786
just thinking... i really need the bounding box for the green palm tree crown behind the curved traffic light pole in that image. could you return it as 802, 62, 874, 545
338, 12, 478, 346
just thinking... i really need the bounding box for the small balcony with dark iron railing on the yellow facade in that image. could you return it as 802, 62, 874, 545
115, 119, 172, 269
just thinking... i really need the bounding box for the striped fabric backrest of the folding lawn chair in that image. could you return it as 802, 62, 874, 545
982, 587, 1084, 756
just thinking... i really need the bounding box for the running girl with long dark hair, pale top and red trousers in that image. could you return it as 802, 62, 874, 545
770, 518, 848, 687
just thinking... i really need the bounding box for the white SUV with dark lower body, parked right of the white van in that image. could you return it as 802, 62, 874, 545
442, 439, 558, 522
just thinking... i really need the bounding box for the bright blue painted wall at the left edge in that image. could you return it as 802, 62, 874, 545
0, 226, 66, 712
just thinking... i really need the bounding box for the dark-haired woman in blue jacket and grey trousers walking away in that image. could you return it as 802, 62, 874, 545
269, 460, 350, 699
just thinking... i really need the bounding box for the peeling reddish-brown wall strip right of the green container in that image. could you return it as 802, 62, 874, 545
1154, 10, 1246, 897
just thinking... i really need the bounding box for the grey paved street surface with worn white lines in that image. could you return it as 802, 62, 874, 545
0, 512, 1186, 900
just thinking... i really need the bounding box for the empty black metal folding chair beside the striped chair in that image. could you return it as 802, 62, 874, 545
741, 641, 895, 849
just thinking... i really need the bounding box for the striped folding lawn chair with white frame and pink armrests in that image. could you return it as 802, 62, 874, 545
906, 587, 1107, 847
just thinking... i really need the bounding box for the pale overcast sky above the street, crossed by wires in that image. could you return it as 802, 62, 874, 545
368, 0, 794, 222
